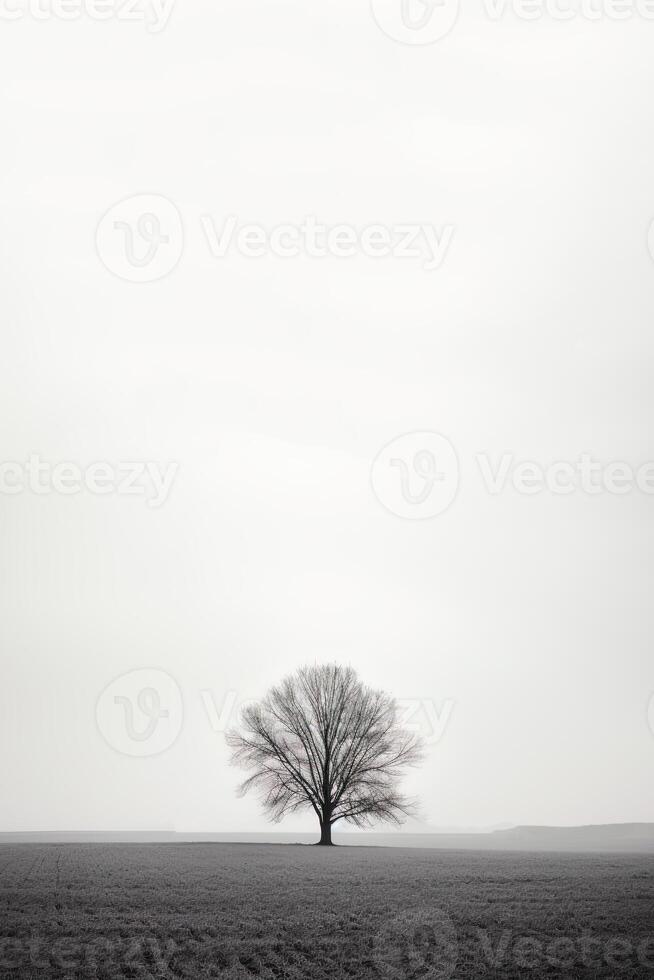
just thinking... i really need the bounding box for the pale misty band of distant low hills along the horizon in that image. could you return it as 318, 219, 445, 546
0, 823, 654, 854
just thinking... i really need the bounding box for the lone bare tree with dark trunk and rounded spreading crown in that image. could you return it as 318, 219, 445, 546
226, 664, 422, 845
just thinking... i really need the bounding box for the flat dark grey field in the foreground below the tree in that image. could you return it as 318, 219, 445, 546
0, 844, 654, 980
